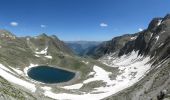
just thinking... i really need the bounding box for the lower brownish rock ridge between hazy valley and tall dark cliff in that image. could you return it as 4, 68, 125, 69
86, 33, 138, 58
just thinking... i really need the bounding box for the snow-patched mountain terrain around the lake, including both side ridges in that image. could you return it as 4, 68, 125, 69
0, 14, 170, 100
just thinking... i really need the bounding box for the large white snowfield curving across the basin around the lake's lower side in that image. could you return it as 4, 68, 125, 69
0, 50, 151, 100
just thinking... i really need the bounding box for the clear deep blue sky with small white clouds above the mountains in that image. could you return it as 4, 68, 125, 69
0, 0, 170, 41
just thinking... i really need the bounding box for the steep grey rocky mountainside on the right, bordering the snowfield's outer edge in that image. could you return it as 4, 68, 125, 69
100, 14, 170, 100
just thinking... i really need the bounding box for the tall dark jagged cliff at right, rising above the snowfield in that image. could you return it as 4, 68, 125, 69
119, 15, 170, 64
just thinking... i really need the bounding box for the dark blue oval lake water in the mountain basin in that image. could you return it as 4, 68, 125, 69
28, 66, 75, 83
